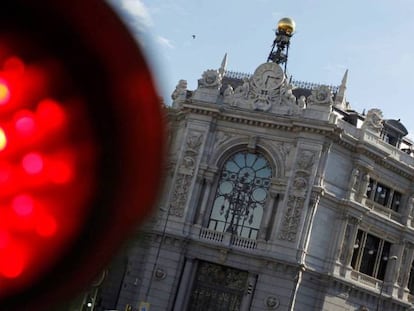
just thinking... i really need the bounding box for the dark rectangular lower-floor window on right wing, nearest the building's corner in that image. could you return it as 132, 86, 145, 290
351, 230, 391, 280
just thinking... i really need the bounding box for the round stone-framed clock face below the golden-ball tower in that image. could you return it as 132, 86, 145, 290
252, 63, 285, 90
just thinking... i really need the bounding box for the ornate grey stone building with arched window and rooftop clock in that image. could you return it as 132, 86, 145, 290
89, 59, 414, 311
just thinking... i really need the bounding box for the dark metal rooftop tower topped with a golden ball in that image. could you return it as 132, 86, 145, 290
267, 17, 296, 72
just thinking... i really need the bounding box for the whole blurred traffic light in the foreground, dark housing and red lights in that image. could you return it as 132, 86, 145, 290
0, 0, 164, 310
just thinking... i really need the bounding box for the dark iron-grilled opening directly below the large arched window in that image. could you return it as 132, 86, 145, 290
187, 261, 248, 311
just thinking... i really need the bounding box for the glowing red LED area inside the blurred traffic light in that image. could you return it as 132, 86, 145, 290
0, 47, 97, 297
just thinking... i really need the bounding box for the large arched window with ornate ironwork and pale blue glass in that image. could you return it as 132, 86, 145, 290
208, 151, 272, 239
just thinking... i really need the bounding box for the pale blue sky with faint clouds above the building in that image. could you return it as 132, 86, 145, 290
107, 0, 414, 138
